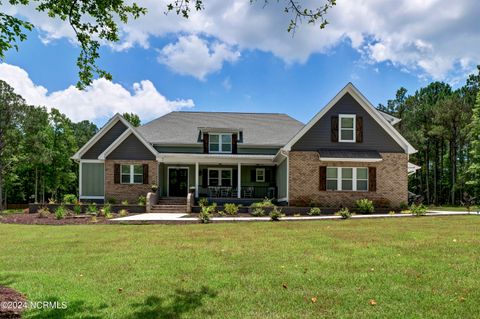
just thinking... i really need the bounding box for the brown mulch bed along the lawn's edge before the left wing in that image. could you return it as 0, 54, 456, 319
0, 214, 124, 225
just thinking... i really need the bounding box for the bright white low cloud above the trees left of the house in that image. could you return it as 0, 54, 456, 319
0, 63, 194, 122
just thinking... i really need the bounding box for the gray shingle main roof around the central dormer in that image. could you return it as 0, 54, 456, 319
137, 112, 304, 146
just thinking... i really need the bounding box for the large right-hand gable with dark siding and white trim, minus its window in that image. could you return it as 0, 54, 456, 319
283, 83, 417, 154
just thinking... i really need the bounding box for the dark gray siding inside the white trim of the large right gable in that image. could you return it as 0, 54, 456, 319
292, 93, 404, 153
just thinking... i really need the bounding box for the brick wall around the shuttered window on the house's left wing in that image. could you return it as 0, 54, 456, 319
105, 160, 158, 204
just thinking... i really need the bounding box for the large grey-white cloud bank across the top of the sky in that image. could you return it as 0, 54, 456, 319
3, 0, 480, 80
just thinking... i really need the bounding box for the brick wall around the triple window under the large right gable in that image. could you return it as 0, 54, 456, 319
288, 151, 408, 208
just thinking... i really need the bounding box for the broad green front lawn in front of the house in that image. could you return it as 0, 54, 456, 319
0, 216, 480, 319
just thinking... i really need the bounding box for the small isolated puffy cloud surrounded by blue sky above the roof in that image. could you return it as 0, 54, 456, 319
158, 35, 240, 80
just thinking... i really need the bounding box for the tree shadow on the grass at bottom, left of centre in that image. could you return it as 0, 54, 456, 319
126, 286, 217, 319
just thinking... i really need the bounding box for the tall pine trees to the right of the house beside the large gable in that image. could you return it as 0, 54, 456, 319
378, 66, 480, 205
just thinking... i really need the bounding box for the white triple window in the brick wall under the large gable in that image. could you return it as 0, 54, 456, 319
327, 167, 368, 191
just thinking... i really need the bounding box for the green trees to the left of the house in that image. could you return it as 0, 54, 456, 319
0, 80, 140, 210
